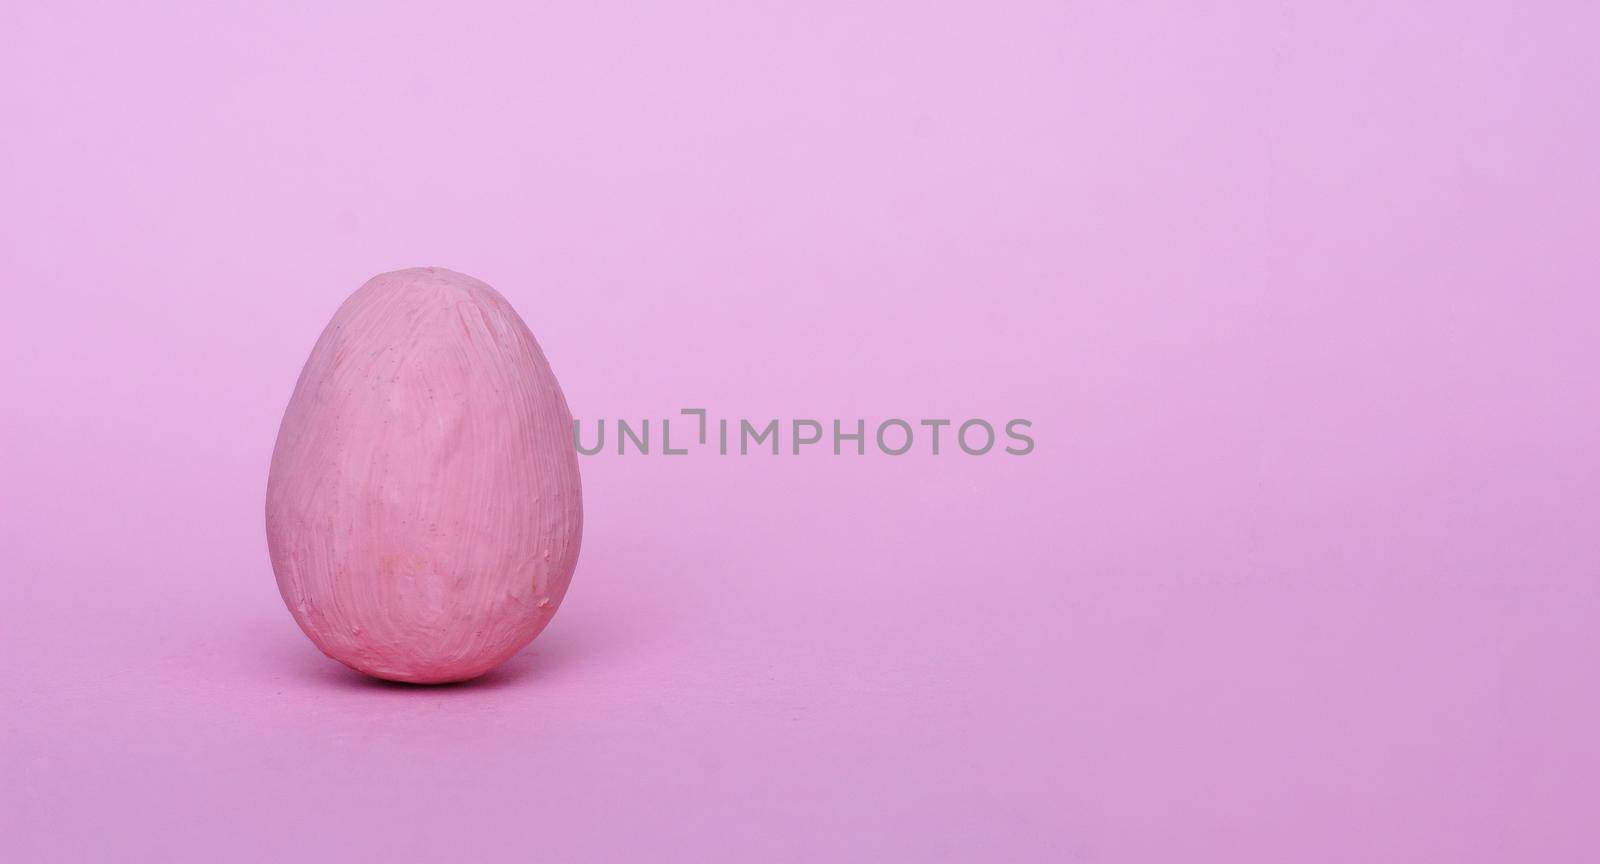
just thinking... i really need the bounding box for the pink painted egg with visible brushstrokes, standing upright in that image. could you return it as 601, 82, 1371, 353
267, 267, 582, 683
